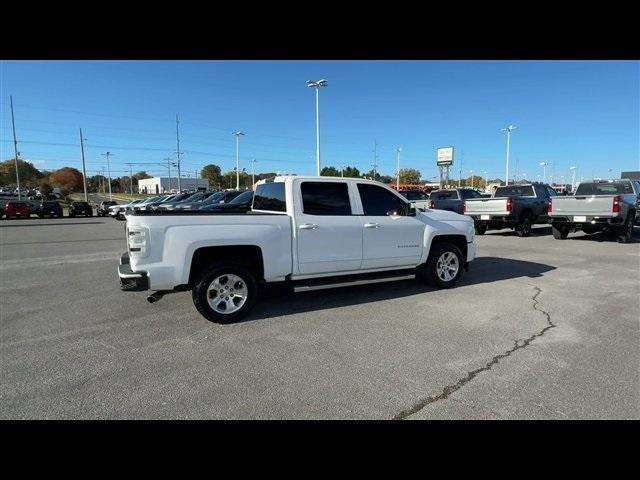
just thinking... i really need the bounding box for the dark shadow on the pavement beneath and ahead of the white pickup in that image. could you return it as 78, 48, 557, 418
248, 257, 556, 322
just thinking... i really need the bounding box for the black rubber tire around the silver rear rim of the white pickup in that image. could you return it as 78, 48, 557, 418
191, 263, 258, 323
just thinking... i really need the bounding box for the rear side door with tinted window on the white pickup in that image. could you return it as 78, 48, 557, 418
294, 180, 362, 275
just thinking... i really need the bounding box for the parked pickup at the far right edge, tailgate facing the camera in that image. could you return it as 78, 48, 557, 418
549, 180, 640, 243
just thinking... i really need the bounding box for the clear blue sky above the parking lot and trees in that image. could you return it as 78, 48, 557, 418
0, 60, 640, 181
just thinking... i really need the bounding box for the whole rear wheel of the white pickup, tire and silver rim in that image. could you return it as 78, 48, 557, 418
191, 262, 258, 323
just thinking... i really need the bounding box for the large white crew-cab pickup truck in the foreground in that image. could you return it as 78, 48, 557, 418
118, 176, 476, 323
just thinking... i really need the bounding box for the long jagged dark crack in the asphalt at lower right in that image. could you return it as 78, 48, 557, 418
393, 285, 556, 420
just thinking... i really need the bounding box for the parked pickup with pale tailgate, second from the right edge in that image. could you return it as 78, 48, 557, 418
464, 183, 558, 237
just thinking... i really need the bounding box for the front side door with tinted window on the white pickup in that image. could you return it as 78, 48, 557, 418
357, 183, 424, 269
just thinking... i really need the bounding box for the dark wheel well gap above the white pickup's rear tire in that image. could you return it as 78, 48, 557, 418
189, 245, 264, 285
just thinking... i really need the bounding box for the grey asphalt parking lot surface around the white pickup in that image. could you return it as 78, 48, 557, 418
0, 213, 640, 419
